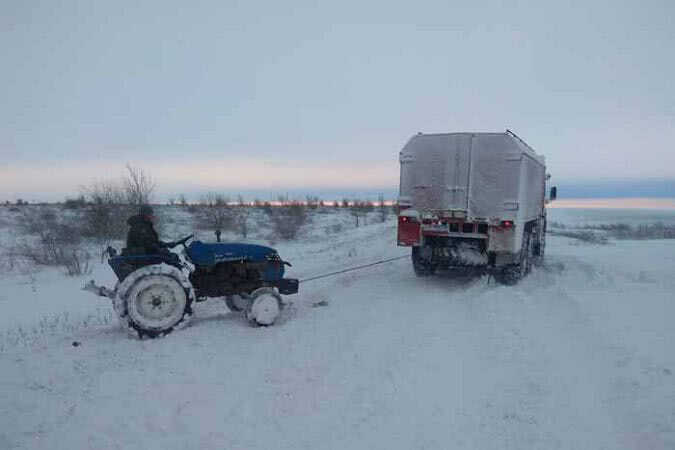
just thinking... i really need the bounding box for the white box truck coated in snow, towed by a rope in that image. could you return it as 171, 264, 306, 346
398, 130, 556, 284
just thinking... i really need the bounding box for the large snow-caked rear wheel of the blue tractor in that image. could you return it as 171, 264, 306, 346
113, 264, 195, 339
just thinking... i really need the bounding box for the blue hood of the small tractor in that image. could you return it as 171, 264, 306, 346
187, 241, 277, 266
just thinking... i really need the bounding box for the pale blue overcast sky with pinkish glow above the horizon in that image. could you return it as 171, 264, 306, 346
0, 0, 675, 200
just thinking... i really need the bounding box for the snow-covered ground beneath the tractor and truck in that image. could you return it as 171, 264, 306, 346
0, 206, 675, 450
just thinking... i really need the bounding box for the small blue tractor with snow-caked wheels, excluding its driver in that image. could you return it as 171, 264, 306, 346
84, 235, 298, 338
